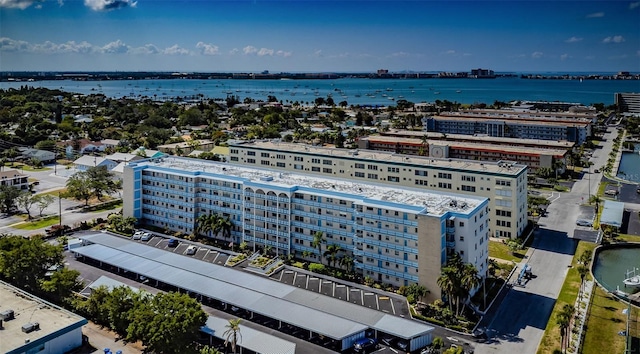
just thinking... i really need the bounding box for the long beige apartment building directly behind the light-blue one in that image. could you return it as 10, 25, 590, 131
229, 141, 528, 238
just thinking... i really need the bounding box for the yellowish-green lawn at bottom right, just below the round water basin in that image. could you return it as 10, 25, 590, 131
582, 287, 627, 354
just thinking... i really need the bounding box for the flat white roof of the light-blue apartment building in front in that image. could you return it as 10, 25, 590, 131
129, 157, 486, 215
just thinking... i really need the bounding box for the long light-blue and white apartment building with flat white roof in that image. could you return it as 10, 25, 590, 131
123, 157, 490, 298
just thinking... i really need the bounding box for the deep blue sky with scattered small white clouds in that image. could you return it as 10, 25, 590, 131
0, 0, 640, 72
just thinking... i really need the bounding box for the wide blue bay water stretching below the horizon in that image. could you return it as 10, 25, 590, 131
0, 77, 640, 106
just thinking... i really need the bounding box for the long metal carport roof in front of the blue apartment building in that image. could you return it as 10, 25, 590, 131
73, 233, 433, 350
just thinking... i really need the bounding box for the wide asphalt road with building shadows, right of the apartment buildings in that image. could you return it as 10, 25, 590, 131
475, 129, 617, 354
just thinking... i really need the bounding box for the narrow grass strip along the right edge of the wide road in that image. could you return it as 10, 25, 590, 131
537, 241, 596, 354
